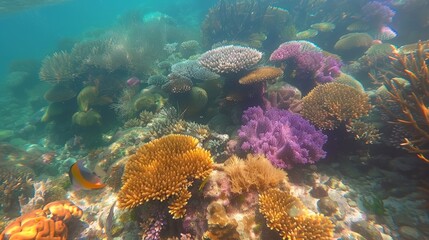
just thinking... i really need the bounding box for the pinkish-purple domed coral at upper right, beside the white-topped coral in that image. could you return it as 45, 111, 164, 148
270, 41, 342, 92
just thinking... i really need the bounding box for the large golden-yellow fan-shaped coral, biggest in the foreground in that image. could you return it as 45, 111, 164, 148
118, 134, 213, 218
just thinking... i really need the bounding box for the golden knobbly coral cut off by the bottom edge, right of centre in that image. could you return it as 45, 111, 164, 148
259, 188, 334, 240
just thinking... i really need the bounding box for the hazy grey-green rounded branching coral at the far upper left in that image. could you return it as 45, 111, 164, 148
39, 51, 79, 83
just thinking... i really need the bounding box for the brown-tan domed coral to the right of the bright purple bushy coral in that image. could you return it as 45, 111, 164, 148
301, 82, 371, 130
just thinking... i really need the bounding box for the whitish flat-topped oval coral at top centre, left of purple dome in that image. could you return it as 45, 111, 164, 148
198, 45, 262, 74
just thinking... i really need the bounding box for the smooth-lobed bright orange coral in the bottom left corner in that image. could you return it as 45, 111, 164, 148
0, 201, 82, 240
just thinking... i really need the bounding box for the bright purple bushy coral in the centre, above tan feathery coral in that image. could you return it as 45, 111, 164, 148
236, 107, 327, 168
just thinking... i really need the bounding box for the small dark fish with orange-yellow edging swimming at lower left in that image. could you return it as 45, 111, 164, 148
69, 161, 106, 190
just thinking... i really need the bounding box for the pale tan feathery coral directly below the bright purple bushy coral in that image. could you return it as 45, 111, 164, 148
224, 154, 287, 193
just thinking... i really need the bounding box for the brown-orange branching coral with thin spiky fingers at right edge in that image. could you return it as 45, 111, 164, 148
376, 43, 429, 163
